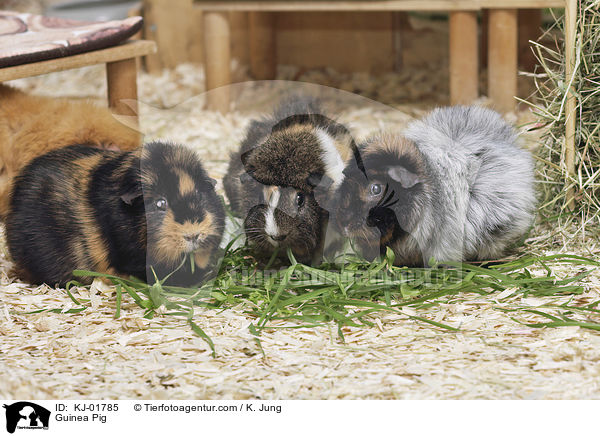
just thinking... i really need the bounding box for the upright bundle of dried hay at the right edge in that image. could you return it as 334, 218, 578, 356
530, 0, 600, 245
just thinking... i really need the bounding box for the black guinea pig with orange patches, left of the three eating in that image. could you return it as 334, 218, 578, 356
6, 142, 224, 286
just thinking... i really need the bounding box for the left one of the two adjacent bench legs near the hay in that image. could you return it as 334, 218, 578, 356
450, 11, 479, 104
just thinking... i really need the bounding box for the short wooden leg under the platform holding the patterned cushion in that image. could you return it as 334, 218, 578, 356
106, 58, 138, 128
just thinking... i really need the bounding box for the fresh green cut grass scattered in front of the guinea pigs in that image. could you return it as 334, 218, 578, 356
24, 247, 600, 355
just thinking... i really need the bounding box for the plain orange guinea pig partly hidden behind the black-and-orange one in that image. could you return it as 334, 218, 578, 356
0, 84, 142, 219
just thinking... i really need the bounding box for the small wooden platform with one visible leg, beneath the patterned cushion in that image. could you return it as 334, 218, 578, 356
0, 40, 156, 122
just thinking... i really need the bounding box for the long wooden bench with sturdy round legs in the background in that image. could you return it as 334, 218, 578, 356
194, 0, 565, 112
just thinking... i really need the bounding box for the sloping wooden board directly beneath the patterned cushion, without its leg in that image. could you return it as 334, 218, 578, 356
0, 40, 156, 82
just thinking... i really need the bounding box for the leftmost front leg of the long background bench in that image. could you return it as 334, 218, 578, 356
204, 11, 231, 113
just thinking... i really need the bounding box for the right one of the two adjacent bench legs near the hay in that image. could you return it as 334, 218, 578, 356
488, 9, 518, 112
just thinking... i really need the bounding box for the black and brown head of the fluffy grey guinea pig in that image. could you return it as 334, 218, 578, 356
331, 136, 433, 266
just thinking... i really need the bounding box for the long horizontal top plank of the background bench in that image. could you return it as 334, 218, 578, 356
197, 0, 565, 11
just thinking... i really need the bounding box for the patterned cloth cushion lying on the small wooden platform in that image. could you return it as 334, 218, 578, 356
0, 10, 142, 68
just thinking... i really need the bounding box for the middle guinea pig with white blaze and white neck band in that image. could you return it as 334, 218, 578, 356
223, 97, 356, 263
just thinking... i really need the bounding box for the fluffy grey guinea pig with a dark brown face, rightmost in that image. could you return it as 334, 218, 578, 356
333, 106, 536, 266
